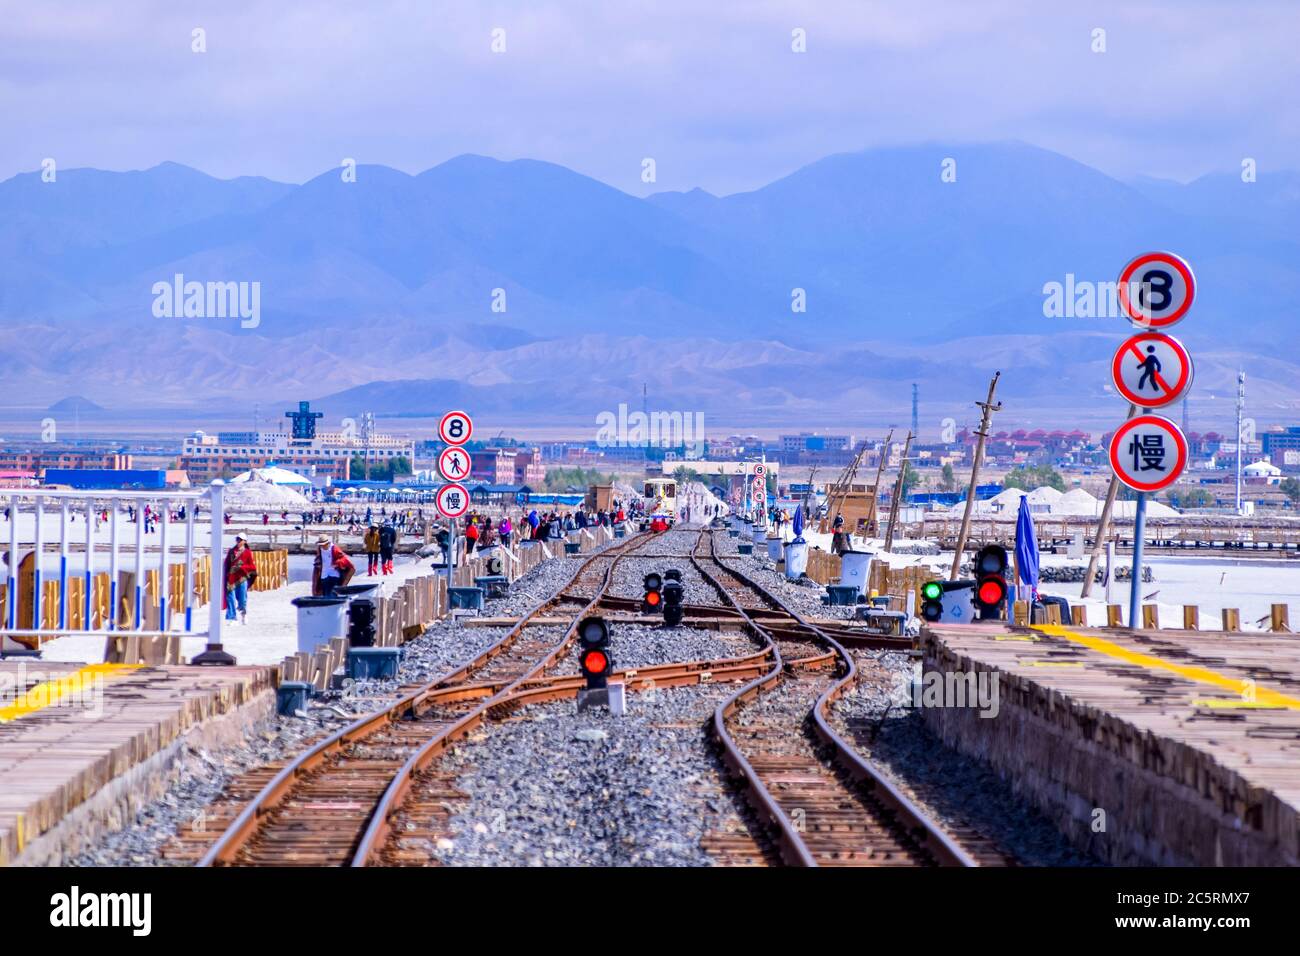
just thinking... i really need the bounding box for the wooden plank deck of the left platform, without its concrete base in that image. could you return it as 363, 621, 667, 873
0, 658, 273, 865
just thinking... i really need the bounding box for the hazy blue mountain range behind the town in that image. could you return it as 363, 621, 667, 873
0, 142, 1300, 428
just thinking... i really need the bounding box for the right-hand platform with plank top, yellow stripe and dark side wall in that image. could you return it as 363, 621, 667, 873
920, 626, 1300, 866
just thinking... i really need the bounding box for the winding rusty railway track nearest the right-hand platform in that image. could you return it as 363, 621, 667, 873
692, 533, 987, 866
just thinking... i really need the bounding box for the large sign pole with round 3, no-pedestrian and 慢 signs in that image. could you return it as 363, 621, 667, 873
1099, 252, 1196, 627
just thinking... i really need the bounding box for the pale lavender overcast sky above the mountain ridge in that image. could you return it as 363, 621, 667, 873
0, 0, 1300, 195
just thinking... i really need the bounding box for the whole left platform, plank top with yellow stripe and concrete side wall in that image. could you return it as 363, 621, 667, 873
0, 658, 274, 865
